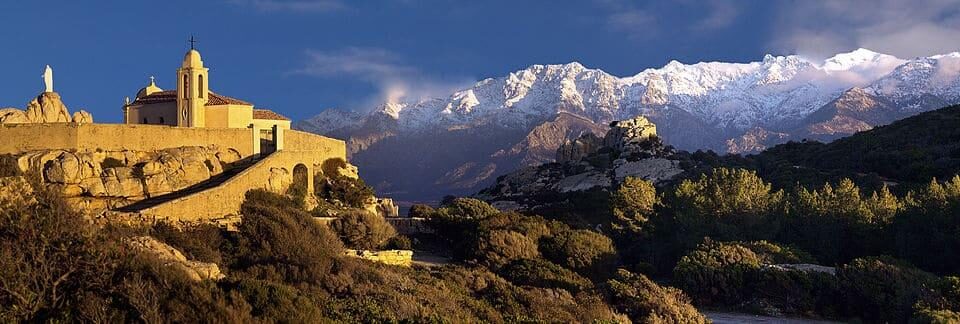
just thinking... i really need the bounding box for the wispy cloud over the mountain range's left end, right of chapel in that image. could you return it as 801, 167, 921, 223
292, 47, 476, 107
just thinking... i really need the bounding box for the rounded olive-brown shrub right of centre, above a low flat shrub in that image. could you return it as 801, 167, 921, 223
540, 230, 617, 278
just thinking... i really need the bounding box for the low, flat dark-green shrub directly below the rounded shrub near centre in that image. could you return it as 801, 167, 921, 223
499, 259, 593, 293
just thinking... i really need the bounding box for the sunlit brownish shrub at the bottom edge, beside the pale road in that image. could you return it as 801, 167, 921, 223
603, 269, 708, 323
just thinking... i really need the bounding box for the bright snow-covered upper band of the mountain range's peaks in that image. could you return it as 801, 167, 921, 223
300, 48, 960, 130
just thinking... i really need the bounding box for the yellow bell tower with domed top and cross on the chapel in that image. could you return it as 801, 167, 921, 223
177, 37, 210, 127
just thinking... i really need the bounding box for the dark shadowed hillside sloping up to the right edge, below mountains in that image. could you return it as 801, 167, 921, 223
748, 106, 960, 190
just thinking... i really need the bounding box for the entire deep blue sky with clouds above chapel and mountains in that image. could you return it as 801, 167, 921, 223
0, 0, 960, 122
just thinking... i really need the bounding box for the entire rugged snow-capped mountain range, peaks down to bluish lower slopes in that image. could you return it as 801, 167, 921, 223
297, 49, 960, 197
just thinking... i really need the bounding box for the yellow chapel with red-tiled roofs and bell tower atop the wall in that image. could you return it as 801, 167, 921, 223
123, 48, 290, 130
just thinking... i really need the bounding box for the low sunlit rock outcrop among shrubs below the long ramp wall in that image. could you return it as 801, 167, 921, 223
127, 236, 226, 281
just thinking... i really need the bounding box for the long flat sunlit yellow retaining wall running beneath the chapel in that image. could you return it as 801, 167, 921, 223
0, 123, 255, 157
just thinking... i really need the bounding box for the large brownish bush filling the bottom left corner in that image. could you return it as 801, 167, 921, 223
0, 185, 118, 322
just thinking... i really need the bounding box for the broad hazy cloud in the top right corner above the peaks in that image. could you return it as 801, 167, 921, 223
770, 0, 960, 58
